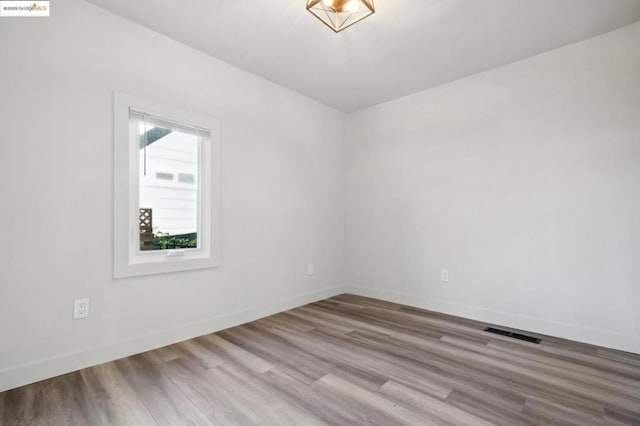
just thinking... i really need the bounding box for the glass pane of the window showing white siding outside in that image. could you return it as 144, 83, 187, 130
131, 114, 200, 251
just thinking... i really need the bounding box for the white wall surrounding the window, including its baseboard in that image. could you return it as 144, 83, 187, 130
0, 0, 344, 391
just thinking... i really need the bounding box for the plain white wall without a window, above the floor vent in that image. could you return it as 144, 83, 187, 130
345, 23, 640, 353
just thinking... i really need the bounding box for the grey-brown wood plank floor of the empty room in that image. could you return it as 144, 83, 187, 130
0, 295, 640, 426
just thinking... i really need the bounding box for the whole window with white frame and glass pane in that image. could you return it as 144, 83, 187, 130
114, 93, 220, 278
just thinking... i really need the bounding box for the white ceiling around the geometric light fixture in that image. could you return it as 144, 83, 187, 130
88, 0, 640, 112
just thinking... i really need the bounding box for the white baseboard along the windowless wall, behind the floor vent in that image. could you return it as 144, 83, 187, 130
346, 286, 640, 354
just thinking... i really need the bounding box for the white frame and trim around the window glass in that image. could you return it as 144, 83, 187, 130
113, 92, 220, 278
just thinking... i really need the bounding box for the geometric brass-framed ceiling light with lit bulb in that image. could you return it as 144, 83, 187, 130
307, 0, 376, 33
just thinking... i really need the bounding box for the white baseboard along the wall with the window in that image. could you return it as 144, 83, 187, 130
0, 287, 345, 392
